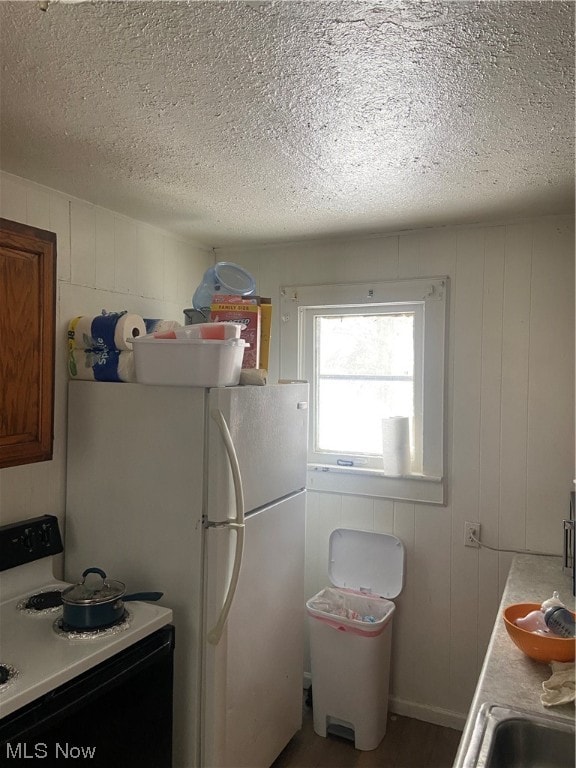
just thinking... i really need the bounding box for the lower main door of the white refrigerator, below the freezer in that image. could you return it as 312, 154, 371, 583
201, 491, 305, 768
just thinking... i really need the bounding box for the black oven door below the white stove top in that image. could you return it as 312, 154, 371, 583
0, 626, 174, 768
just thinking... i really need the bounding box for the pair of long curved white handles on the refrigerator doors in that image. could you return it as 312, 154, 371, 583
206, 408, 244, 645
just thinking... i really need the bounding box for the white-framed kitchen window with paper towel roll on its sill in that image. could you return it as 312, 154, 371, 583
281, 277, 448, 503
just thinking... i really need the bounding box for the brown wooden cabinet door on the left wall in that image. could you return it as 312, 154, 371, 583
0, 219, 56, 467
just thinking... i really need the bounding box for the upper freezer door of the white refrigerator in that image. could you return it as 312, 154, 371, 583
208, 384, 308, 521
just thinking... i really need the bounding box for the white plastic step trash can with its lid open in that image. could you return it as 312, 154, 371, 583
306, 528, 405, 750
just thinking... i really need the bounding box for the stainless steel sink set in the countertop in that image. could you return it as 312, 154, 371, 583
464, 704, 574, 768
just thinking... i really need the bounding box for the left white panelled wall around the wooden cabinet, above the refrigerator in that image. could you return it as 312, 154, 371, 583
0, 173, 213, 544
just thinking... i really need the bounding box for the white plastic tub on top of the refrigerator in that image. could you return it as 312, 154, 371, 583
133, 336, 246, 387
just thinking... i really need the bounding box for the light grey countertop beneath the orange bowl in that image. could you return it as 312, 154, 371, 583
454, 555, 574, 768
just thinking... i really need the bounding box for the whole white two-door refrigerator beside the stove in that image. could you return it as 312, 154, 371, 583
65, 381, 308, 768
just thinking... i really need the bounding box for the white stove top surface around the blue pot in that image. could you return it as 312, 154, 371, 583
0, 518, 172, 718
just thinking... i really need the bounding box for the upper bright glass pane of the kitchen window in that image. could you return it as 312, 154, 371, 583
316, 312, 414, 376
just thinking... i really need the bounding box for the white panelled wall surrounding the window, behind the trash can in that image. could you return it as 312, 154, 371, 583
218, 217, 574, 726
